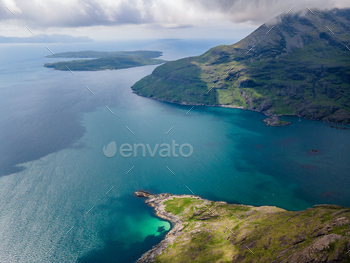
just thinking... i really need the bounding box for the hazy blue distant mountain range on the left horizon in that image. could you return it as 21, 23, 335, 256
0, 34, 94, 43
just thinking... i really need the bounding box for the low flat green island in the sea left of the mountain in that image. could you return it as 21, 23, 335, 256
44, 50, 165, 71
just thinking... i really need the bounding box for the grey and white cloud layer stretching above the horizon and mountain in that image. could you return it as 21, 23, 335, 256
0, 0, 350, 28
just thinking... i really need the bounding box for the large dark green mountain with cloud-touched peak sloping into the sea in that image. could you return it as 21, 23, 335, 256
132, 9, 350, 124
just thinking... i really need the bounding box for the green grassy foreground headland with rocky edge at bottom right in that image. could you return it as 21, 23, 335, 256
135, 191, 350, 263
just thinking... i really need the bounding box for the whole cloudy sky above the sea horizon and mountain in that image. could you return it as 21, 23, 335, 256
0, 0, 350, 40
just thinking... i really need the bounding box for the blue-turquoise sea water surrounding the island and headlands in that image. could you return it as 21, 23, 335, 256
0, 40, 350, 262
